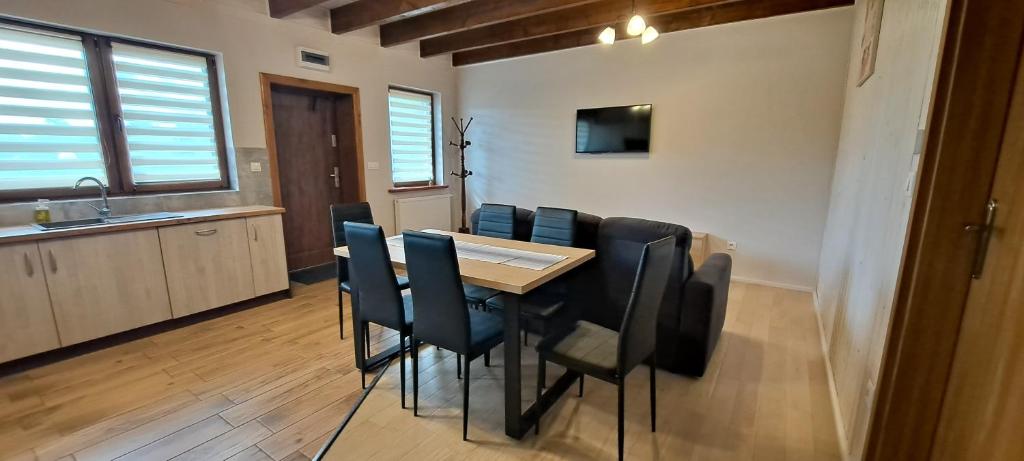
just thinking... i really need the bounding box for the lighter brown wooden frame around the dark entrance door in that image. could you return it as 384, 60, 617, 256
259, 72, 367, 207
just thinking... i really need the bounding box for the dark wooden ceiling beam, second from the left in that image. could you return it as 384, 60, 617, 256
331, 0, 468, 34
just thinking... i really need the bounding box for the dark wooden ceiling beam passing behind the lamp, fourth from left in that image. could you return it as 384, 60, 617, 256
420, 0, 729, 57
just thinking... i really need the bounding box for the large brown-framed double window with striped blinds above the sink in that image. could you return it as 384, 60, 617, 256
0, 19, 228, 200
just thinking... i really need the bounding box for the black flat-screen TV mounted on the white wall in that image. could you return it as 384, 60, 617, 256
577, 104, 651, 154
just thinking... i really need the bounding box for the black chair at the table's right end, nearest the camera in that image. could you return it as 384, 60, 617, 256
535, 237, 676, 460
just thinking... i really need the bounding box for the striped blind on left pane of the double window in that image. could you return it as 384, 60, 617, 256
0, 27, 106, 191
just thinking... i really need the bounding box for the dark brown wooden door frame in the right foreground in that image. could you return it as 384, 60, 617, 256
864, 0, 1024, 461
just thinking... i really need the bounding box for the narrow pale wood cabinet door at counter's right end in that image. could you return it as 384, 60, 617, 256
246, 214, 288, 296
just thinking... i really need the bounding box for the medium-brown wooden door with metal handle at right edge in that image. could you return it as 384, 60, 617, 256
933, 45, 1024, 461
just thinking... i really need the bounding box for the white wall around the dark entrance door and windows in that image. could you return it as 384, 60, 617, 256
0, 0, 456, 229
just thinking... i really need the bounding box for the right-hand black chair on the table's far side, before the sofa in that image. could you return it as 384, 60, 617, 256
486, 207, 579, 344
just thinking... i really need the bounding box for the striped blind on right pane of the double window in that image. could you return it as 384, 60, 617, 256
112, 42, 222, 184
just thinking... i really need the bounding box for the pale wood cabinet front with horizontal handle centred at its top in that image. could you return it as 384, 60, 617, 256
160, 218, 255, 318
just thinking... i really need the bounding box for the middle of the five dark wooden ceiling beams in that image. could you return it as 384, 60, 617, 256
381, 0, 598, 46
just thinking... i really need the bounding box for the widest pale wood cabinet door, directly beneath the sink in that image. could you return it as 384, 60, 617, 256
39, 229, 171, 346
